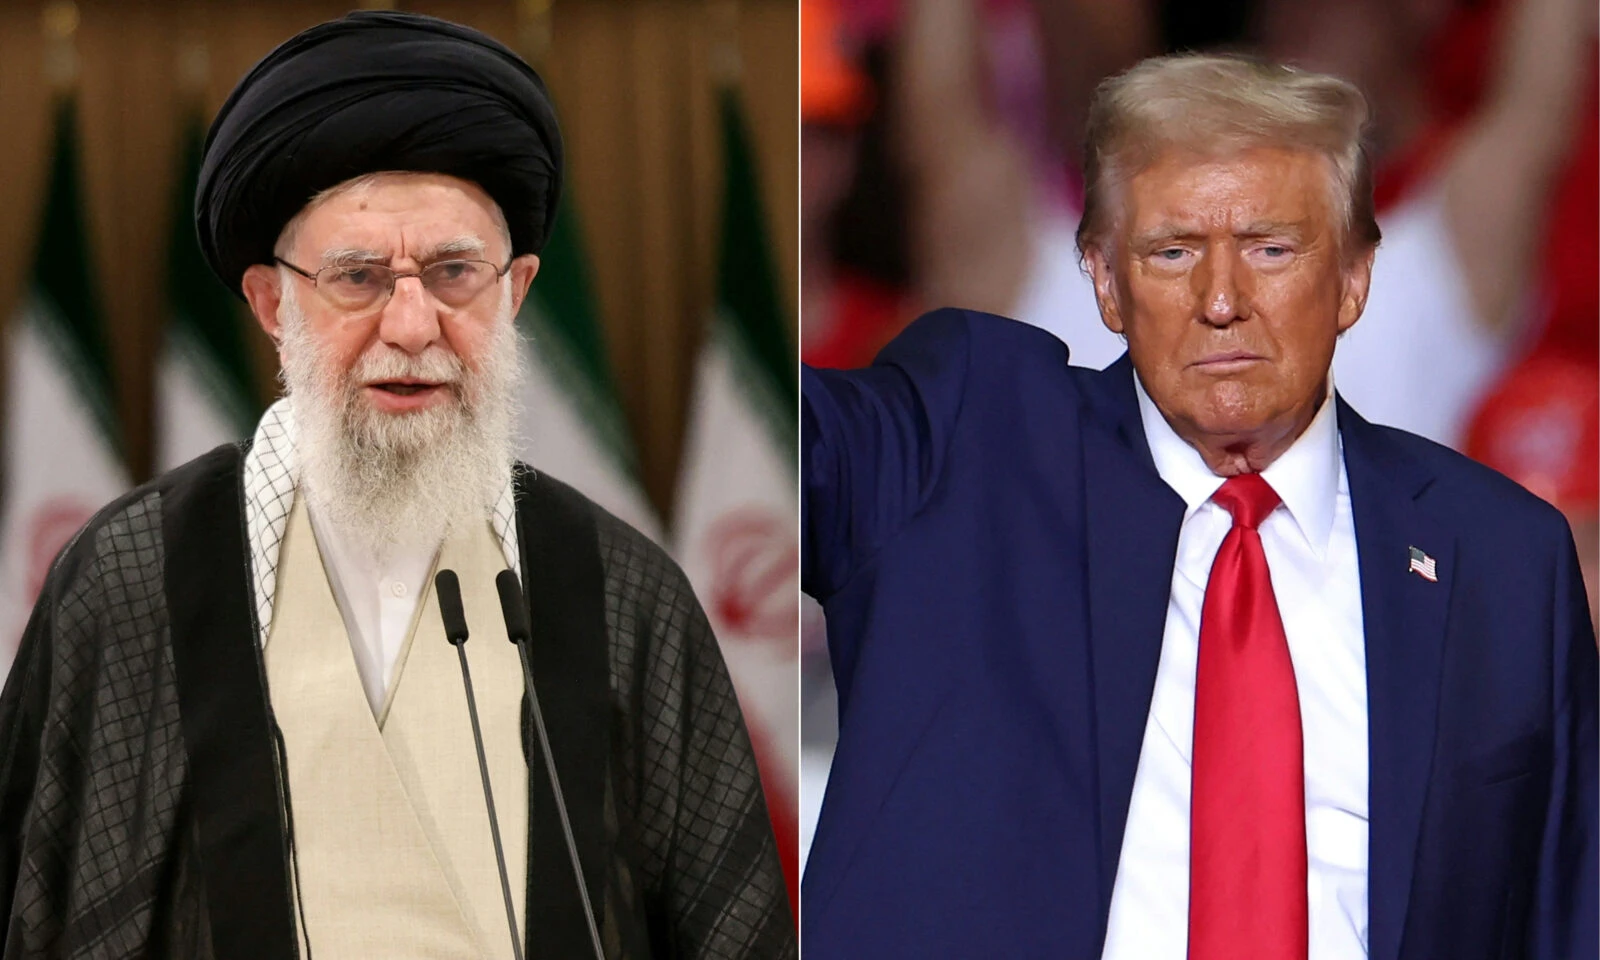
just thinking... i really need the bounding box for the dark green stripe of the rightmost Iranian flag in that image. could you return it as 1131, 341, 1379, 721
717, 88, 797, 451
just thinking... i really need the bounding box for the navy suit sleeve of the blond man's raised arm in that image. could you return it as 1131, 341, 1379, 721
800, 310, 970, 602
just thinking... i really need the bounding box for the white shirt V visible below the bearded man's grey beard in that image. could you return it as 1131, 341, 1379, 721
306, 504, 445, 717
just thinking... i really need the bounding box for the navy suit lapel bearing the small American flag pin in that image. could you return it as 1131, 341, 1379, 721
1339, 400, 1456, 960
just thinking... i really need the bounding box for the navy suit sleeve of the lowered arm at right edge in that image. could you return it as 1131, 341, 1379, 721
1528, 525, 1600, 960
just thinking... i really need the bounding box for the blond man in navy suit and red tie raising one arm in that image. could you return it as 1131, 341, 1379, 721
802, 56, 1600, 960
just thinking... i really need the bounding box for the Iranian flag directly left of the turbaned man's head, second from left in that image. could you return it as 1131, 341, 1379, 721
155, 117, 261, 470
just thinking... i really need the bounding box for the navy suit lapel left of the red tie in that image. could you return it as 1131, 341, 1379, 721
1083, 355, 1184, 936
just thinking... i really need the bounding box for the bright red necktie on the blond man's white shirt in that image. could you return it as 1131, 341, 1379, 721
1189, 474, 1309, 960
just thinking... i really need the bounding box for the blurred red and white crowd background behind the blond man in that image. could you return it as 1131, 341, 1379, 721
800, 0, 1600, 856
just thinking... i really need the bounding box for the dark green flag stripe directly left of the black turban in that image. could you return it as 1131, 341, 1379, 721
166, 115, 262, 435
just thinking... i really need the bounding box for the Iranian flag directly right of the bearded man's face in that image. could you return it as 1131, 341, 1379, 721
517, 192, 661, 541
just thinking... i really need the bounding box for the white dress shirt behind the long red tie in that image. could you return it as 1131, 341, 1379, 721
1102, 378, 1366, 960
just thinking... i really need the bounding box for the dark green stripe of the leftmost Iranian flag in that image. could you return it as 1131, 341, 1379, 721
30, 96, 122, 450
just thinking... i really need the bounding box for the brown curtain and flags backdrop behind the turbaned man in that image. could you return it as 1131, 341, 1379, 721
0, 0, 798, 908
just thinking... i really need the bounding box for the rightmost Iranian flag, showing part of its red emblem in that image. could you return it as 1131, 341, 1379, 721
674, 88, 800, 902
